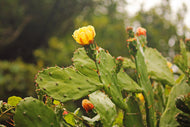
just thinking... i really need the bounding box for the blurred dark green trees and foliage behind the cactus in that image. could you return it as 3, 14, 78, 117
0, 0, 190, 100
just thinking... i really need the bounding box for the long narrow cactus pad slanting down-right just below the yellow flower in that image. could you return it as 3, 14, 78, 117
96, 48, 127, 109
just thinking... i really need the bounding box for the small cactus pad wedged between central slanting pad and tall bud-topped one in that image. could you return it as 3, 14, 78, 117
117, 69, 142, 93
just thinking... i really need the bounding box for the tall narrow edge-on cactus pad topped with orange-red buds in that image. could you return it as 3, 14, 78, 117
127, 27, 154, 127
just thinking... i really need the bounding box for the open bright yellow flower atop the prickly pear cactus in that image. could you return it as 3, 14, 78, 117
73, 25, 96, 46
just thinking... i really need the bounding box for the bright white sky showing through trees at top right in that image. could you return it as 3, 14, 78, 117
126, 0, 190, 28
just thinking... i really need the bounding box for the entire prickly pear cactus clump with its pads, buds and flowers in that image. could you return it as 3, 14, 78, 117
1, 26, 190, 127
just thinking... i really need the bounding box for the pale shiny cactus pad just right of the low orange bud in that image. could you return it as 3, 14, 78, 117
89, 91, 117, 127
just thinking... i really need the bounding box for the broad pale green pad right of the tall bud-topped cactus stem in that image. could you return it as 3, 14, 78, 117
145, 48, 175, 85
